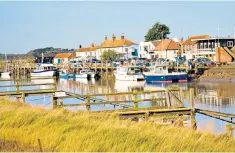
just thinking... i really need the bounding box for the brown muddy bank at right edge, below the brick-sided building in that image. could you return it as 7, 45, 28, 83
199, 68, 235, 82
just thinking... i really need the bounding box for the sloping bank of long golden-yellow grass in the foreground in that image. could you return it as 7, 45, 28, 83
0, 100, 235, 152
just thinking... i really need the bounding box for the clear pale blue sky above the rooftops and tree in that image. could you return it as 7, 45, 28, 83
0, 1, 235, 53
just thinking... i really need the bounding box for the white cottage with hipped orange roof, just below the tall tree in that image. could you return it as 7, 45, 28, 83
153, 39, 180, 60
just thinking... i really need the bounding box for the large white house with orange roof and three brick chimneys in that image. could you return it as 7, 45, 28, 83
96, 35, 138, 59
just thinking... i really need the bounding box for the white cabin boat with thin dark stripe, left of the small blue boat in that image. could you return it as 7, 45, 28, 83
31, 64, 55, 77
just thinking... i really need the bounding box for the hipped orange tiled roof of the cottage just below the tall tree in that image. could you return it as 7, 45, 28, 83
154, 39, 180, 51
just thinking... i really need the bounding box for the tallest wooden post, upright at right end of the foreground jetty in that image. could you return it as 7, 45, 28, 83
189, 88, 197, 129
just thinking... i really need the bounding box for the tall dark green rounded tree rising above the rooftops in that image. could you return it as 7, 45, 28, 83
145, 22, 170, 41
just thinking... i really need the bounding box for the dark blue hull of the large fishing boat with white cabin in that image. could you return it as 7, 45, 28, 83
144, 73, 188, 83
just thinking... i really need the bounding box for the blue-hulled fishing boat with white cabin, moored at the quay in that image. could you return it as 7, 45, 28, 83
143, 64, 188, 83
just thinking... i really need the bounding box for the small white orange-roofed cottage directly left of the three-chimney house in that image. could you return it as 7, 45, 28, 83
76, 43, 98, 60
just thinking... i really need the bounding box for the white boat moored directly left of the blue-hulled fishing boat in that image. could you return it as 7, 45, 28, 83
114, 67, 144, 81
